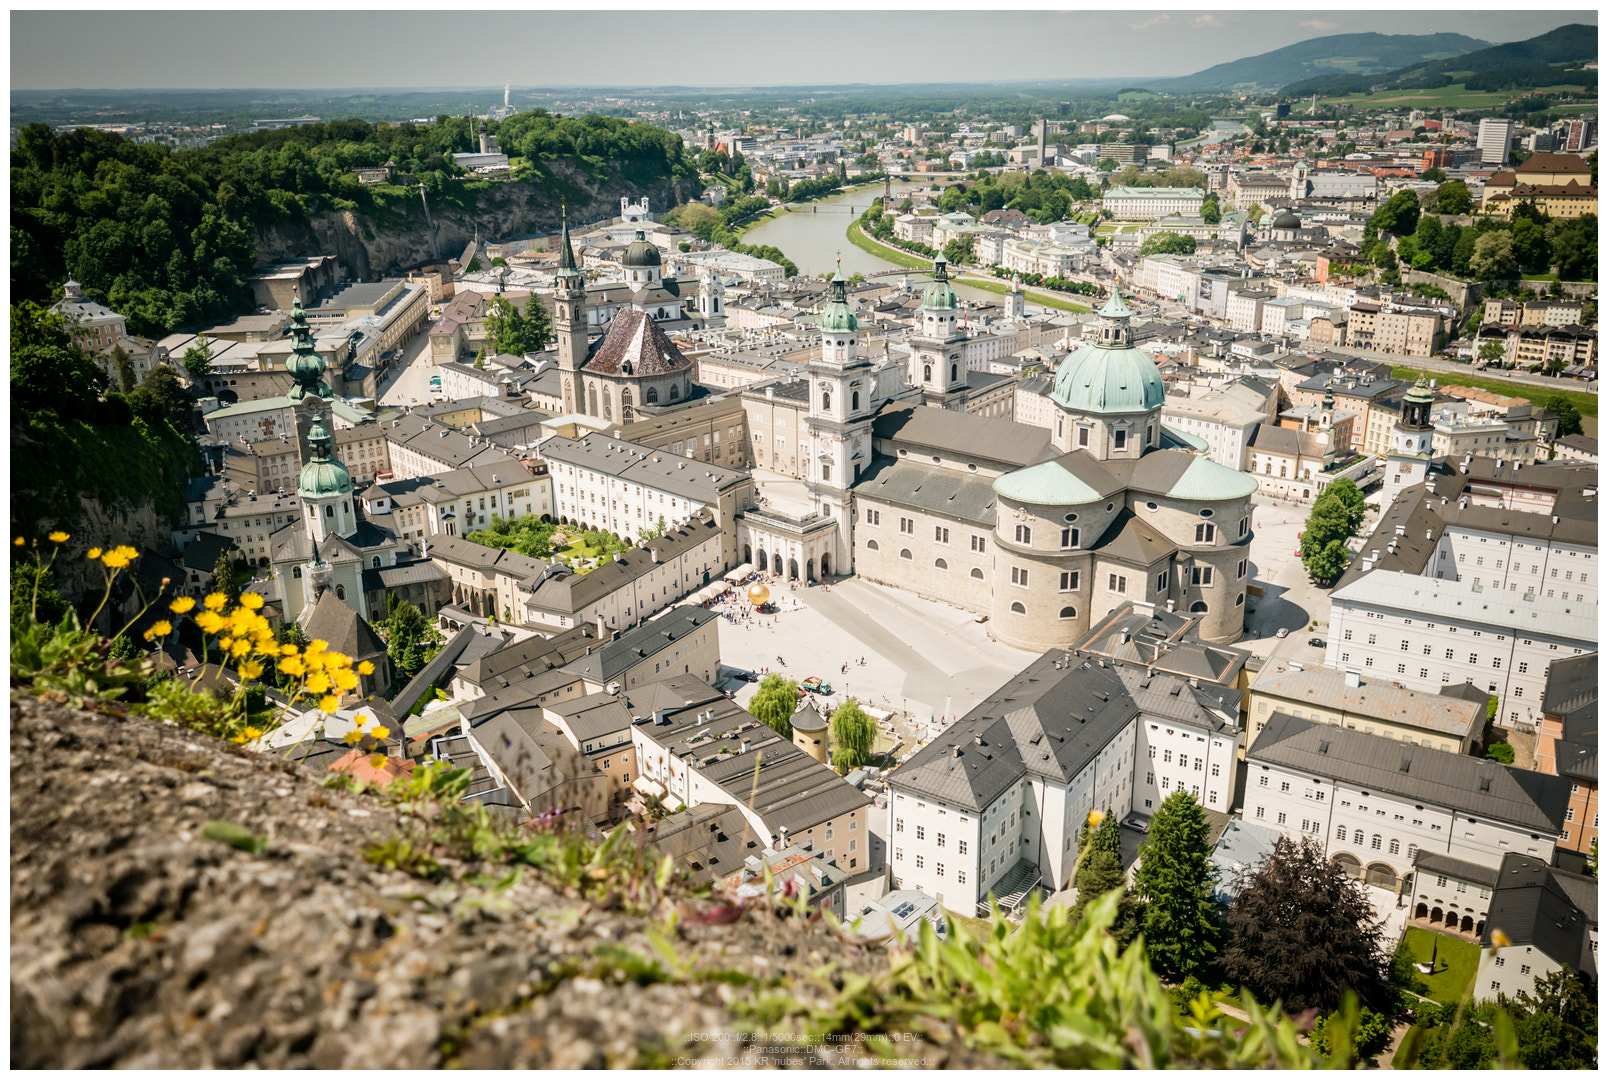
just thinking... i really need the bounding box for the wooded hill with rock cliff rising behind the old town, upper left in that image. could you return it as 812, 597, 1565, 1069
11, 109, 696, 334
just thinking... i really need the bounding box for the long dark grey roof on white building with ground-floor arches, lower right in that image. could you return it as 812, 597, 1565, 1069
1246, 712, 1569, 834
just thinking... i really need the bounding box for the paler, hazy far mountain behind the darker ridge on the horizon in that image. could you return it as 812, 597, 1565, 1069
1145, 27, 1485, 93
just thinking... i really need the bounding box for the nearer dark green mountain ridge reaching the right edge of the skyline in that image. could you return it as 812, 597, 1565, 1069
1279, 23, 1597, 96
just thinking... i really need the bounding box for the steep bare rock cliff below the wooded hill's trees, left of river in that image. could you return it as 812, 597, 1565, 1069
254, 162, 695, 280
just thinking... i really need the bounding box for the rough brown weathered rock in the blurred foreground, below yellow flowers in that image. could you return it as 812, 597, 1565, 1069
11, 696, 999, 1069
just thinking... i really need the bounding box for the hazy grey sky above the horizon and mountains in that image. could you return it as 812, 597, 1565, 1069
11, 0, 1597, 90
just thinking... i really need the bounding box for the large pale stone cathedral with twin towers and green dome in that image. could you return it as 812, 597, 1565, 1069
775, 276, 1256, 651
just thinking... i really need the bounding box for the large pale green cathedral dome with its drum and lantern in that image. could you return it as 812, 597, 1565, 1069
1050, 291, 1166, 461
